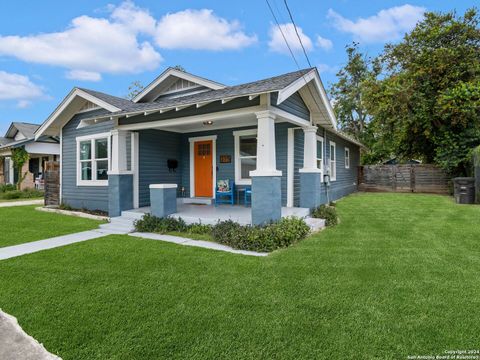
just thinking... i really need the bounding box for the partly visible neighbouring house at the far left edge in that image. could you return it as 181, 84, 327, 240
0, 122, 60, 189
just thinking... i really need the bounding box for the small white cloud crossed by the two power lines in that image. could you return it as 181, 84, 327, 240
268, 23, 313, 54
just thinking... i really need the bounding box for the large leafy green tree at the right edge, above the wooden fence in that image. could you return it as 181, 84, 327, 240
365, 9, 480, 174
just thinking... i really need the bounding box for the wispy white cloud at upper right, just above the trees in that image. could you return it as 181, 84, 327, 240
328, 4, 425, 43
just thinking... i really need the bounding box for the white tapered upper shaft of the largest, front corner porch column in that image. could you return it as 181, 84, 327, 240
250, 110, 282, 176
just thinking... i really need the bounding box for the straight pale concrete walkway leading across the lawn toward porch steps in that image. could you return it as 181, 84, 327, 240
0, 230, 106, 260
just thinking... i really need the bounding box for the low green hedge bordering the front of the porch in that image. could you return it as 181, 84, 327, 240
135, 214, 310, 252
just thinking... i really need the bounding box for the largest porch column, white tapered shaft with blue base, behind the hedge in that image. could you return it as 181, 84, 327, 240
250, 111, 282, 225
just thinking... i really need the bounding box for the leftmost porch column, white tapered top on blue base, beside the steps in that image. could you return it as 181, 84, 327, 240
108, 129, 133, 217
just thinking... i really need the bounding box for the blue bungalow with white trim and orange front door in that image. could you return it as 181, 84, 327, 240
36, 68, 362, 223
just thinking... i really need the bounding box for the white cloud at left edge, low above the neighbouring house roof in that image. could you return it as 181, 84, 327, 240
0, 70, 45, 108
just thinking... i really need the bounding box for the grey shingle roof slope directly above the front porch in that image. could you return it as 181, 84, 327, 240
81, 68, 312, 116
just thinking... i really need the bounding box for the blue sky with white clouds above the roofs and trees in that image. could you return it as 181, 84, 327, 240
0, 0, 473, 136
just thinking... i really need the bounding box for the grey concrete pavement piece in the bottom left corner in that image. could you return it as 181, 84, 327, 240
0, 310, 61, 360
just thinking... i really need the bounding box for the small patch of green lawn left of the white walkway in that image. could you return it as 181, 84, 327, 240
0, 205, 101, 248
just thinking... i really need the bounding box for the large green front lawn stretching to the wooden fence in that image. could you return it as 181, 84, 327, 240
0, 194, 480, 360
